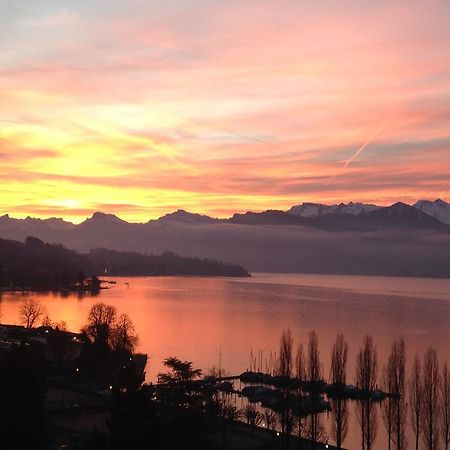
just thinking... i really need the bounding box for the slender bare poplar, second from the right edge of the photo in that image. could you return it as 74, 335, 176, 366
422, 348, 440, 450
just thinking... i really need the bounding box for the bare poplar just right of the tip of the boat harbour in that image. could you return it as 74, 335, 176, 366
383, 339, 407, 450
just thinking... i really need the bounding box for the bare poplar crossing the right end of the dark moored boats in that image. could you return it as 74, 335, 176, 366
356, 336, 378, 450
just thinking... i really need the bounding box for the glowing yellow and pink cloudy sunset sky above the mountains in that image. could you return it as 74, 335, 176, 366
0, 0, 450, 221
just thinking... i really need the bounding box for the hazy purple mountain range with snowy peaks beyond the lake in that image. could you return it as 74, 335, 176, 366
0, 199, 450, 277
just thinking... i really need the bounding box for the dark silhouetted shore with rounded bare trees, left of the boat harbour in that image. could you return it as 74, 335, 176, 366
0, 301, 288, 450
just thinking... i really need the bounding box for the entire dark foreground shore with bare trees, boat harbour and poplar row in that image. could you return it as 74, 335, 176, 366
0, 300, 450, 450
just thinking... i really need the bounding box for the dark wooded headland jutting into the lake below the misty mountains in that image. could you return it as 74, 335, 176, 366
0, 237, 249, 293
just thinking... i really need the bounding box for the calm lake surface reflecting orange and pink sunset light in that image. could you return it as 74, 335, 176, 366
0, 274, 450, 448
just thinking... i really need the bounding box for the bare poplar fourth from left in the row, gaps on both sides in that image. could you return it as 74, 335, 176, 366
330, 334, 348, 448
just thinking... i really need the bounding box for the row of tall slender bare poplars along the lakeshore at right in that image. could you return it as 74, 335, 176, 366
277, 329, 450, 450
